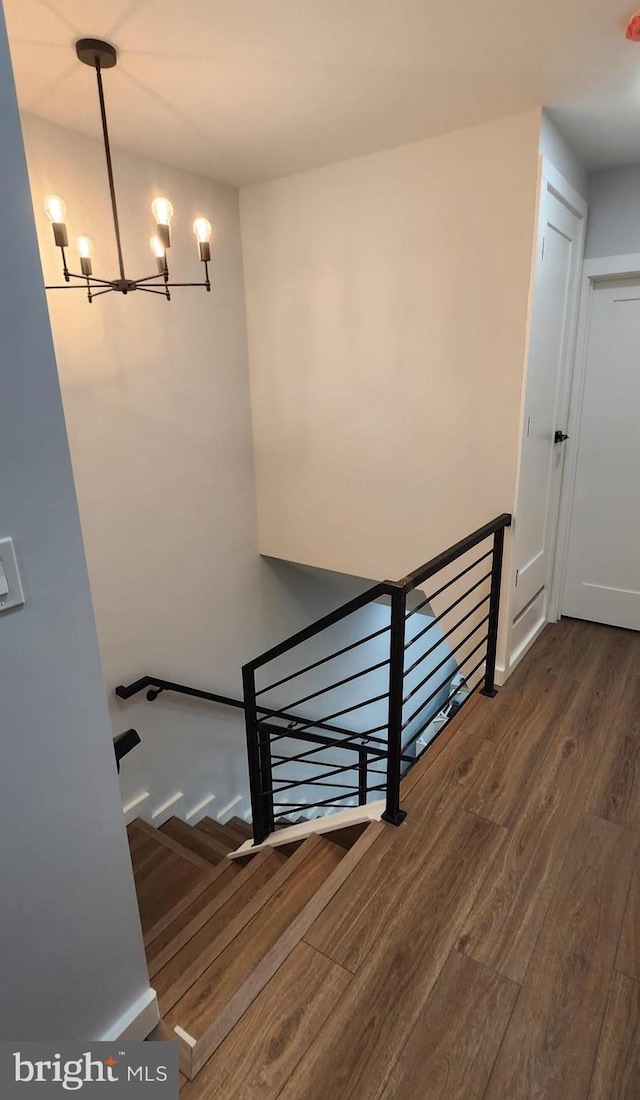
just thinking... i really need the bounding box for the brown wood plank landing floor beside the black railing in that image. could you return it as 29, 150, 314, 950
180, 619, 640, 1100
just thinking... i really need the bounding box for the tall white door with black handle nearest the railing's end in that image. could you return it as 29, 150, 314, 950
510, 167, 586, 663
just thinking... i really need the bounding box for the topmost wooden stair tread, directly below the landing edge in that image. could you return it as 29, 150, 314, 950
167, 837, 344, 1038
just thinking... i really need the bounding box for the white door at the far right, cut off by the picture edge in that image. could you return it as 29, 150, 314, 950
562, 278, 640, 630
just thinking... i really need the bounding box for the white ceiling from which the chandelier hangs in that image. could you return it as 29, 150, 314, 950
3, 0, 640, 184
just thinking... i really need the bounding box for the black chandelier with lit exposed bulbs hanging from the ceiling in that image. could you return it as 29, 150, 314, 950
44, 39, 211, 301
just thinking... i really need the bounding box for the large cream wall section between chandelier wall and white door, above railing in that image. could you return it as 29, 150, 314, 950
241, 111, 540, 578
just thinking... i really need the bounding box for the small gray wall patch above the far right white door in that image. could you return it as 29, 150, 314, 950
585, 164, 640, 260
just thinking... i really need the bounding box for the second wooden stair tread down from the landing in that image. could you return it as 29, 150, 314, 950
147, 850, 286, 985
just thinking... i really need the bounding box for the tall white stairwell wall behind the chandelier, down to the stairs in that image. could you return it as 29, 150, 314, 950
17, 107, 378, 817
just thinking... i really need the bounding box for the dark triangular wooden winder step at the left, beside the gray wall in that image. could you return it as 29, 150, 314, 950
129, 821, 211, 933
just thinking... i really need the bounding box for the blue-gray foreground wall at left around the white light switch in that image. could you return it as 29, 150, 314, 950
0, 11, 148, 1041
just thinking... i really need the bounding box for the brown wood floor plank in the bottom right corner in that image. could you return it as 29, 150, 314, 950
588, 974, 640, 1100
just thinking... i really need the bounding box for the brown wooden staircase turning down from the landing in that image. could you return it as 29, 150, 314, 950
128, 817, 384, 1080
